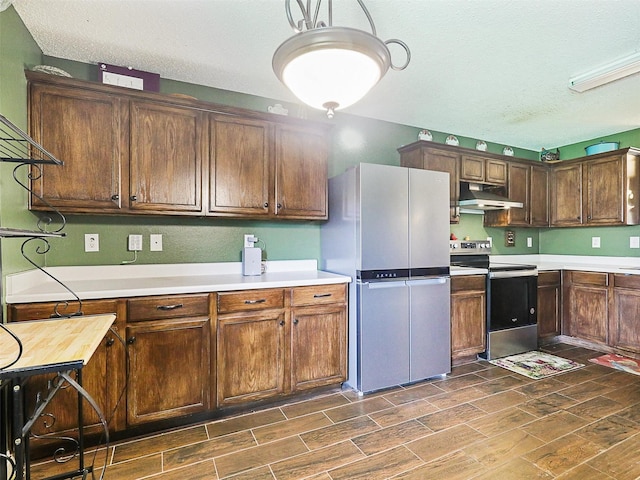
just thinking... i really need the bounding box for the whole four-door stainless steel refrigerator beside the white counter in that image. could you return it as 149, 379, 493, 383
321, 163, 451, 392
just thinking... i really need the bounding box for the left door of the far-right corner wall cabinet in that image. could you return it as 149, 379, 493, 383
549, 163, 582, 227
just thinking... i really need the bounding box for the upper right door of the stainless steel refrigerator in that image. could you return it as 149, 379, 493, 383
408, 168, 449, 268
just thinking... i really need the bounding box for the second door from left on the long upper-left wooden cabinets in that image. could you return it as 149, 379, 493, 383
129, 101, 206, 213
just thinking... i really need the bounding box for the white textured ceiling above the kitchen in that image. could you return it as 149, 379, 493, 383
14, 0, 640, 150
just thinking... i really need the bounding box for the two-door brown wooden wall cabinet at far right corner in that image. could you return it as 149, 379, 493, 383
550, 148, 640, 226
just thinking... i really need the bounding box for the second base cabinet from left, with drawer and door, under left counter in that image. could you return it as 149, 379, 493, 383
126, 294, 211, 426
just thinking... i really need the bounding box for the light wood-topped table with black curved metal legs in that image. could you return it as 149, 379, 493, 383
0, 315, 116, 480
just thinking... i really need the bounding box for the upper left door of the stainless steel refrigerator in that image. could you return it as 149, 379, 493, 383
356, 163, 408, 270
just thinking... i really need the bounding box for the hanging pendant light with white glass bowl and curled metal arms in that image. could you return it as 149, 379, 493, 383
273, 0, 411, 118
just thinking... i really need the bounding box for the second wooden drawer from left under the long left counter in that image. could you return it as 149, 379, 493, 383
127, 294, 209, 322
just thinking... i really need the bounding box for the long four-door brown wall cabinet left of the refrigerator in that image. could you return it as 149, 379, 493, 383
27, 72, 328, 220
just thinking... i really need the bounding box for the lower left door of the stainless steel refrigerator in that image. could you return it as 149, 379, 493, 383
356, 281, 410, 392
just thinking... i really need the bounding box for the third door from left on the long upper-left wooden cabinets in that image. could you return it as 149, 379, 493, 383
208, 116, 274, 217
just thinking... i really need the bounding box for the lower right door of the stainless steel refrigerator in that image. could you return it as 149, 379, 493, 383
407, 276, 451, 382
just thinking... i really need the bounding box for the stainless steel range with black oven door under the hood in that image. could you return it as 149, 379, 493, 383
449, 240, 538, 360
